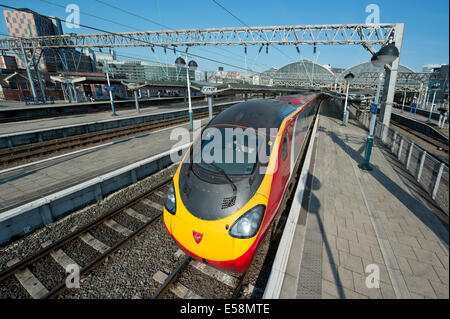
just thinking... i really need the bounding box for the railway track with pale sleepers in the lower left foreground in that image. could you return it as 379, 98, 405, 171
0, 178, 171, 299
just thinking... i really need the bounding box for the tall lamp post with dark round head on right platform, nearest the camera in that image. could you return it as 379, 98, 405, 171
358, 43, 400, 171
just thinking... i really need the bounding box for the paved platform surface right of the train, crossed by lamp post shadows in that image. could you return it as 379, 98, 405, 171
280, 99, 449, 299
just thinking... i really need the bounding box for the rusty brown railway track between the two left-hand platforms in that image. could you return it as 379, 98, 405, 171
0, 110, 223, 169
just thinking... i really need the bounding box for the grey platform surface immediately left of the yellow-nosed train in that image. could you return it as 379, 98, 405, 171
0, 120, 200, 213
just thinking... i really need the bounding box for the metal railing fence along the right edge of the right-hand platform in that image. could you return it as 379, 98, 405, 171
357, 112, 449, 215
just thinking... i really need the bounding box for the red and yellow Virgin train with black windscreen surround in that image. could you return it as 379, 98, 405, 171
163, 92, 324, 274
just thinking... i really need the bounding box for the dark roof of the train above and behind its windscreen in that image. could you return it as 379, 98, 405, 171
208, 95, 314, 130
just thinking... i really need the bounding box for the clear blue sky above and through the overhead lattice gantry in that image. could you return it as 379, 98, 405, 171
0, 0, 449, 72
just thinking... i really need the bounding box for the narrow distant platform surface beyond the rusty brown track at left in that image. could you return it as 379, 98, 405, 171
0, 99, 240, 135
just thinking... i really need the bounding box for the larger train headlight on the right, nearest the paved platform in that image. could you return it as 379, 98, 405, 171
229, 205, 266, 238
